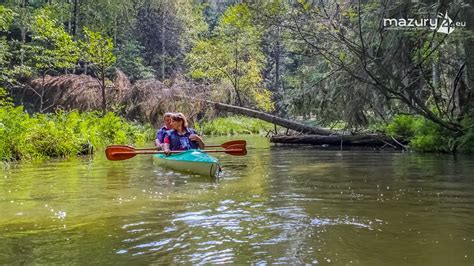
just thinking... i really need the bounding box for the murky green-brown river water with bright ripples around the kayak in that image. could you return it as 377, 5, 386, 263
0, 137, 474, 265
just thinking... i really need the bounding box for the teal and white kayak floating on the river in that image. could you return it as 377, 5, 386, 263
153, 150, 220, 177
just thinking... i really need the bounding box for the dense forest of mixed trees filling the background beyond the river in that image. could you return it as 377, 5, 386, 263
0, 0, 474, 158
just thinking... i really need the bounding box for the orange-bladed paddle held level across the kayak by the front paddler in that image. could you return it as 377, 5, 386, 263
105, 145, 247, 161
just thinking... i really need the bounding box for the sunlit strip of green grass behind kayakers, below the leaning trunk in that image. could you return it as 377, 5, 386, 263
195, 116, 274, 136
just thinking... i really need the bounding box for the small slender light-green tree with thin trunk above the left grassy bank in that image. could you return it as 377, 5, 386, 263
81, 28, 116, 115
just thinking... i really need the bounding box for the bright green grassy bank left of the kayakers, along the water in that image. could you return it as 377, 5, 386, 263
0, 93, 154, 161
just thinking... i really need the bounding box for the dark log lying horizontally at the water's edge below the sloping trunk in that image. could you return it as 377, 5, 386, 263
270, 135, 407, 148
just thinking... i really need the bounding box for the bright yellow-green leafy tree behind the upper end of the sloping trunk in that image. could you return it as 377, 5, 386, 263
187, 4, 273, 111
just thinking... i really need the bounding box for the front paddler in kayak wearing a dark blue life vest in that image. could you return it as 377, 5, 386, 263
163, 113, 205, 154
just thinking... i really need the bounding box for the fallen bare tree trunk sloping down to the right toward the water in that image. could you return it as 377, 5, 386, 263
176, 96, 335, 135
